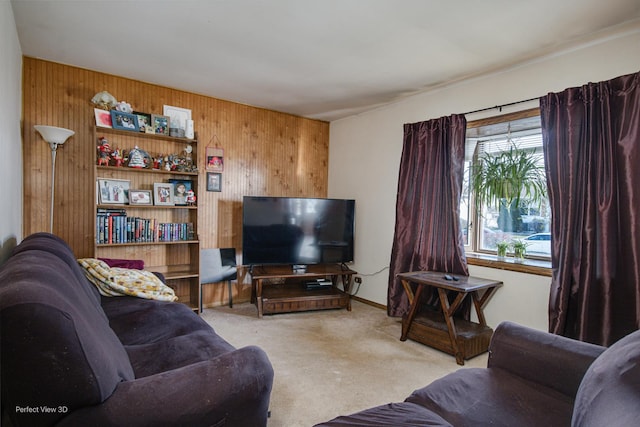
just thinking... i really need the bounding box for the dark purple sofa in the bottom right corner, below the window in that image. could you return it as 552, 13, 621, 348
317, 322, 640, 427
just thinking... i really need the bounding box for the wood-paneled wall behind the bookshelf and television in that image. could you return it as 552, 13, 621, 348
21, 57, 329, 257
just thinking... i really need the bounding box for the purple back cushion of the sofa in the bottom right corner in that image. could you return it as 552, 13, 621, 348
571, 331, 640, 427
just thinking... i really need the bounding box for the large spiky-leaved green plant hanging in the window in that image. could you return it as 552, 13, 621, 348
471, 143, 547, 231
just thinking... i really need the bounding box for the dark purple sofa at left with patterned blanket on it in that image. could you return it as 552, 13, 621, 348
0, 233, 273, 426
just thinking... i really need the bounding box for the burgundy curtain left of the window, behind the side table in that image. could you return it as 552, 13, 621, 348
387, 115, 469, 317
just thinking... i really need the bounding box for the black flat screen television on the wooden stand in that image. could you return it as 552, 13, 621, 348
242, 196, 355, 265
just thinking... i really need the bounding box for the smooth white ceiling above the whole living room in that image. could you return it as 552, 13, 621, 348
11, 0, 640, 121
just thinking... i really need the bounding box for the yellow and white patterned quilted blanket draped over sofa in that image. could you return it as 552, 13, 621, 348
78, 258, 178, 301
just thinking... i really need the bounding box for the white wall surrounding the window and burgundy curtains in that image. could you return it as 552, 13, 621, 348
329, 21, 640, 330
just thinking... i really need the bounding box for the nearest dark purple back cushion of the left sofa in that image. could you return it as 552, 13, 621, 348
0, 239, 134, 425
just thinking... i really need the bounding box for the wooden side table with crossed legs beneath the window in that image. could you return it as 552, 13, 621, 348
398, 271, 502, 365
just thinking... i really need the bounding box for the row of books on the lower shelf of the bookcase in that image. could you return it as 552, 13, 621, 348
96, 209, 195, 245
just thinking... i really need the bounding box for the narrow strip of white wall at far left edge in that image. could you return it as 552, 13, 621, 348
0, 1, 23, 264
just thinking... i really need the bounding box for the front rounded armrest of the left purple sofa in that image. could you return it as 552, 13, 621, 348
59, 346, 273, 426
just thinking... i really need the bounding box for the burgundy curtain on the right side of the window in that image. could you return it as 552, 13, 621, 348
540, 73, 640, 346
